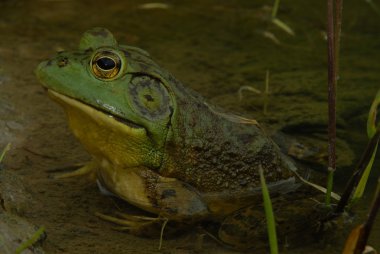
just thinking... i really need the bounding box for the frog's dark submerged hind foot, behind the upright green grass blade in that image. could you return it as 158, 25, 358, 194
218, 193, 325, 253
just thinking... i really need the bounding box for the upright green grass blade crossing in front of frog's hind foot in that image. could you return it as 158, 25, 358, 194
259, 165, 278, 254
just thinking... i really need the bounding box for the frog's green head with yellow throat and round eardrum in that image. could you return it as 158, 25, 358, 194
36, 28, 175, 171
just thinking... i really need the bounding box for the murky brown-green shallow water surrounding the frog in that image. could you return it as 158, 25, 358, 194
0, 0, 380, 253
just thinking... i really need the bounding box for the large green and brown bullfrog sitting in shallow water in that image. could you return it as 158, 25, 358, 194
36, 28, 314, 249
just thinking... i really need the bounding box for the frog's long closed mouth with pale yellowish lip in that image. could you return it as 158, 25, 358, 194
48, 89, 145, 134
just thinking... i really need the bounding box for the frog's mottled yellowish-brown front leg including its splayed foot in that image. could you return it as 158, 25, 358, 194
98, 167, 209, 236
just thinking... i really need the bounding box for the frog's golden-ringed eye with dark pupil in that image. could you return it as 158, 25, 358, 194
91, 51, 121, 80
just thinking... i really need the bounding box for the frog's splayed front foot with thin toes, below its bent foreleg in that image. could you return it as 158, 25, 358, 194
95, 213, 168, 237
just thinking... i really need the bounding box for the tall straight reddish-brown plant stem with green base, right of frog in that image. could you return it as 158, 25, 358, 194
326, 0, 336, 205
